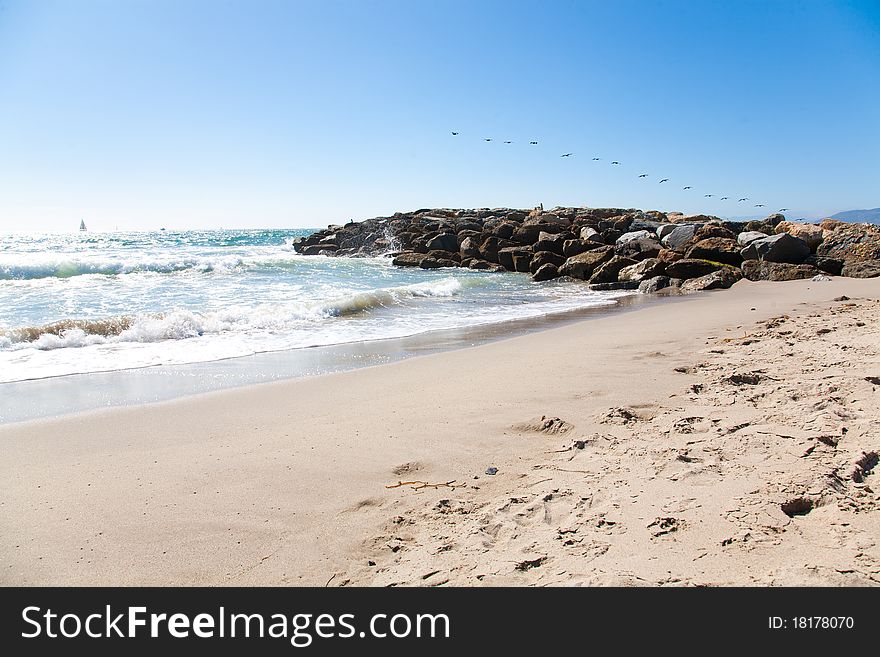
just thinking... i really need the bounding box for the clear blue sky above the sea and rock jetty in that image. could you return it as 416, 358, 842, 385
0, 0, 880, 230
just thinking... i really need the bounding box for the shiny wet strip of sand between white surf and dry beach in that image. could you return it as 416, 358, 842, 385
0, 293, 679, 426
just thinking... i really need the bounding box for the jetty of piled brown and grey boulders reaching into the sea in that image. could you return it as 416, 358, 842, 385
293, 208, 880, 292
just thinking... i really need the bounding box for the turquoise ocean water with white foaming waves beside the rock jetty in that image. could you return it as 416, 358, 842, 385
0, 230, 620, 416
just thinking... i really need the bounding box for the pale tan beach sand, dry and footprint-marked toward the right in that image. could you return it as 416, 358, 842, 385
0, 278, 880, 586
